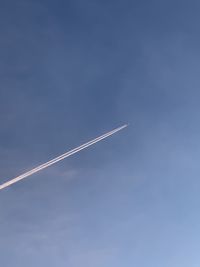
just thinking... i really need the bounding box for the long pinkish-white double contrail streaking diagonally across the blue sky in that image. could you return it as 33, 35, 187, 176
0, 124, 128, 190
